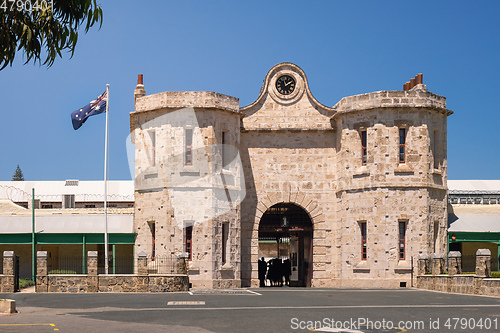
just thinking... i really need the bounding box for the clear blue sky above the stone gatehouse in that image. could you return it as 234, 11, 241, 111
0, 1, 500, 180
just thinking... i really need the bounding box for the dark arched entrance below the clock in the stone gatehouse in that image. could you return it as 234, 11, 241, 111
259, 203, 313, 287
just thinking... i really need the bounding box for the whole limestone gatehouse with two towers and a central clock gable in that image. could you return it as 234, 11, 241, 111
130, 63, 453, 288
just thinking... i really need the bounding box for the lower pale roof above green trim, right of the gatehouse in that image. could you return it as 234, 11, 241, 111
448, 213, 500, 232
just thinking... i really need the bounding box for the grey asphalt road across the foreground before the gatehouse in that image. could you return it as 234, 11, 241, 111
0, 288, 500, 333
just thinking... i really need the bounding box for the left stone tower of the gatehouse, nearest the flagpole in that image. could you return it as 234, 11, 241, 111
130, 76, 244, 288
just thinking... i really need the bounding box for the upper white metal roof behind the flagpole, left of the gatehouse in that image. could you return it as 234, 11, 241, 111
0, 180, 134, 202
